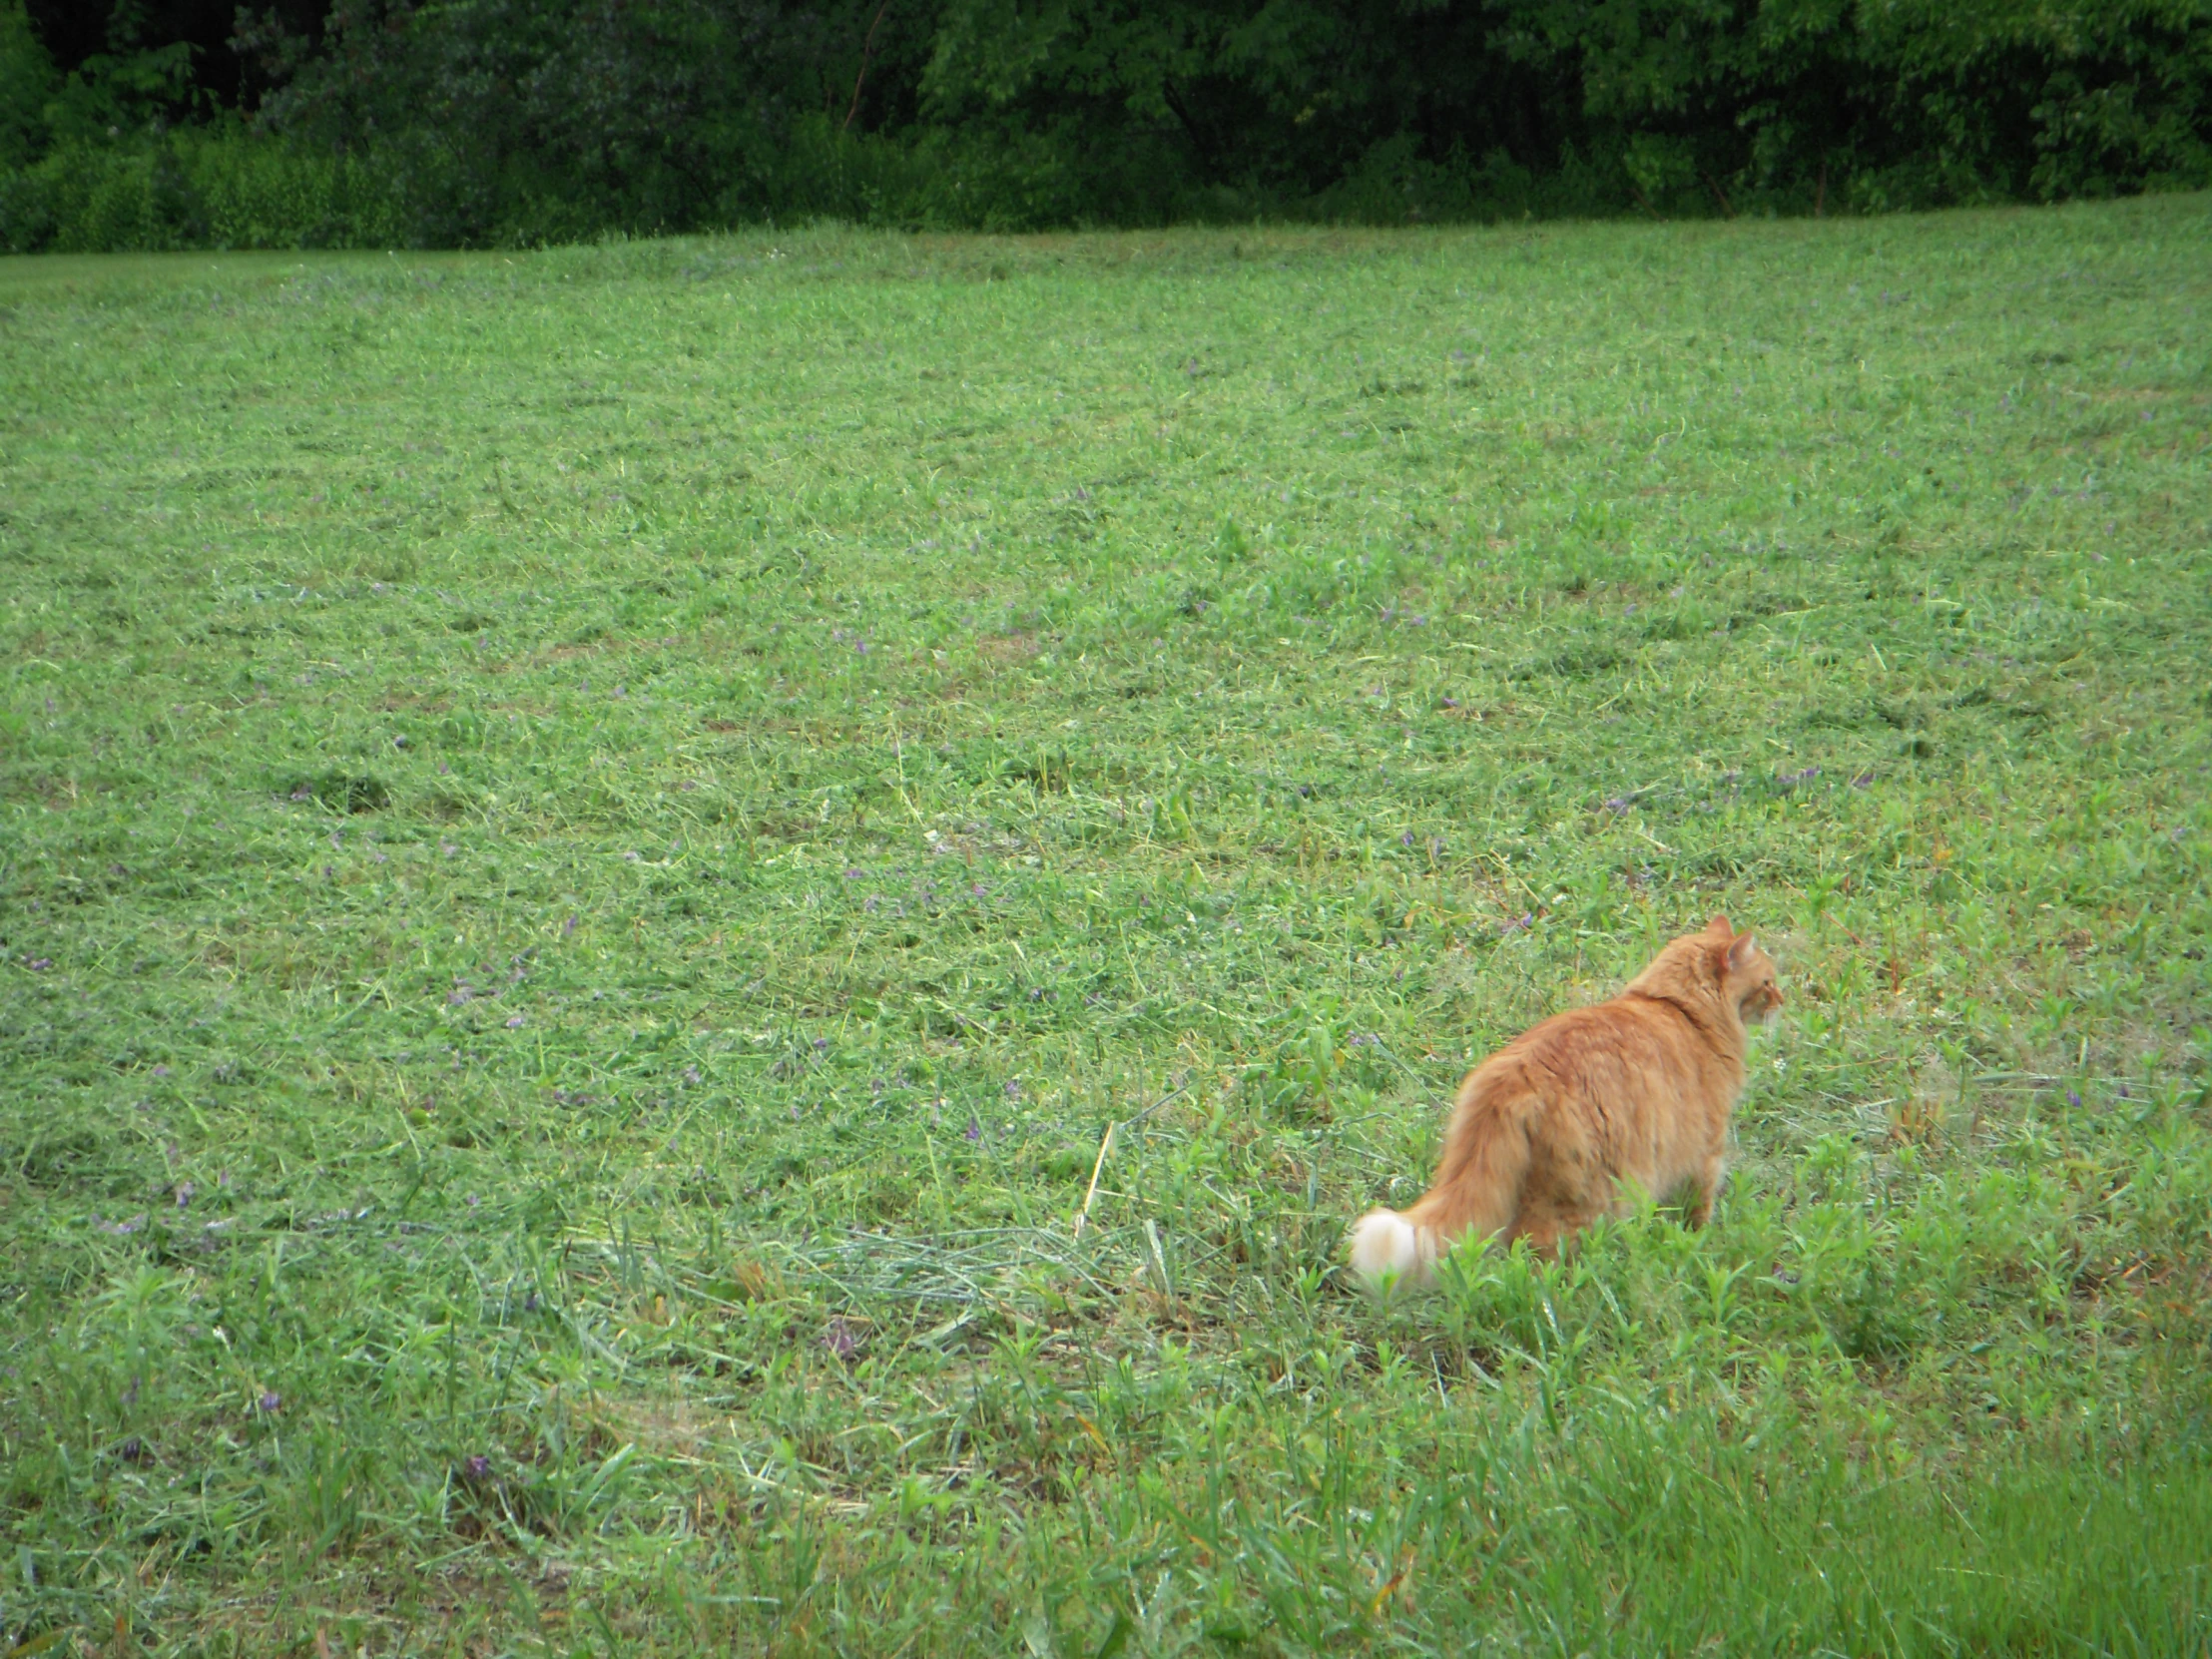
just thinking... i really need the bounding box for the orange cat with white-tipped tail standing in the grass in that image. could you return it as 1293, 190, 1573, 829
1352, 915, 1783, 1288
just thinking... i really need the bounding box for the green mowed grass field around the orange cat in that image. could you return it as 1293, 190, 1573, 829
0, 197, 2212, 1659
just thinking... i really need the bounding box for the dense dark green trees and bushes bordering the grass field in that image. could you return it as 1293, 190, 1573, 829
0, 0, 2212, 248
